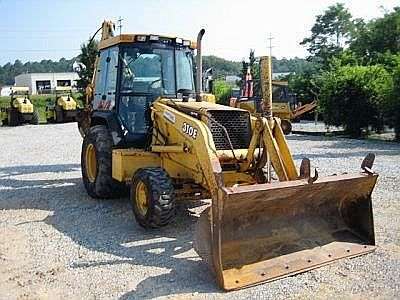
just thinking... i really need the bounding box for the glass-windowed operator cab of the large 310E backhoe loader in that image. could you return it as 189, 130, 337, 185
93, 35, 195, 148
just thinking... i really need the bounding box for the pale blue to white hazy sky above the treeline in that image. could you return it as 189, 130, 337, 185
0, 0, 400, 65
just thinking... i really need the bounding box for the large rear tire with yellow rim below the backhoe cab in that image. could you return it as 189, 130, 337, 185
81, 125, 125, 199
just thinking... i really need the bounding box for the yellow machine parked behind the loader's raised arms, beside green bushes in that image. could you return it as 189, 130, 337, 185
229, 60, 317, 134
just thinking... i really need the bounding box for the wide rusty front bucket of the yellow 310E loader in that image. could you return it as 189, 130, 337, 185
195, 173, 378, 290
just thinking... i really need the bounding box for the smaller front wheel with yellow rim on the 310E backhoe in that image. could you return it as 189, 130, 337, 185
130, 168, 176, 228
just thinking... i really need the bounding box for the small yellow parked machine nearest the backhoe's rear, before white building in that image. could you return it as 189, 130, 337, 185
46, 86, 80, 123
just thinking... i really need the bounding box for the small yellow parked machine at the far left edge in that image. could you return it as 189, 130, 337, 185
0, 86, 39, 126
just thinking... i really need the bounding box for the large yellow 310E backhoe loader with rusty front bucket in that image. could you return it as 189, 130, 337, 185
78, 21, 377, 290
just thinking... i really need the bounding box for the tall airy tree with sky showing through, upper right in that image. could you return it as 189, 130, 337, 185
300, 3, 354, 66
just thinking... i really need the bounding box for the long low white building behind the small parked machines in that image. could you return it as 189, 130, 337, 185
15, 72, 79, 95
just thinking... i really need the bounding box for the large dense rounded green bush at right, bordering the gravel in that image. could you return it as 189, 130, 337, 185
319, 66, 393, 137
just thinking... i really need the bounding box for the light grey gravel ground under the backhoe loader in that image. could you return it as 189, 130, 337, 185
0, 124, 400, 299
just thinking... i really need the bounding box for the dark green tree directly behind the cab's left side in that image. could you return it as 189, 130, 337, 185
77, 40, 99, 89
